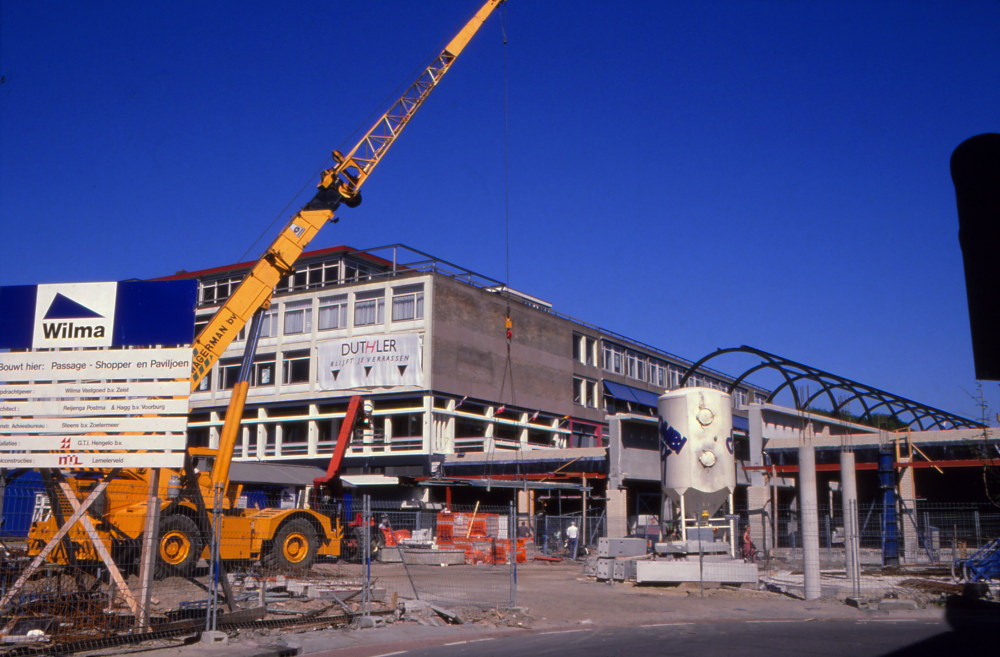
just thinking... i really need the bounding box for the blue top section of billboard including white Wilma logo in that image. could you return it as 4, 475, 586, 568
0, 280, 198, 349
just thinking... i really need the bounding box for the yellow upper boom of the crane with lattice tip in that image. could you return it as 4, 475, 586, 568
191, 0, 504, 390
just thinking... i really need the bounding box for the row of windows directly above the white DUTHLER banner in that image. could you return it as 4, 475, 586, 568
195, 284, 424, 340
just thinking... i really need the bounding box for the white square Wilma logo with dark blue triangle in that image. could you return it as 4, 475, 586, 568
34, 283, 118, 348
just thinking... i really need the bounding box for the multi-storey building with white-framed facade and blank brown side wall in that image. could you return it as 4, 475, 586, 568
160, 245, 767, 508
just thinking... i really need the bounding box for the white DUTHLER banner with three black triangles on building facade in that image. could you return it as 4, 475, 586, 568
318, 333, 424, 390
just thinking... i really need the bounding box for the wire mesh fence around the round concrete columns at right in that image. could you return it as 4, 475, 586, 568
737, 499, 1000, 601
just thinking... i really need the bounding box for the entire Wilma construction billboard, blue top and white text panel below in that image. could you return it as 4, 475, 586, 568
0, 281, 197, 470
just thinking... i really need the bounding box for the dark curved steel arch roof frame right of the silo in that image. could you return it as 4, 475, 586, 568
680, 345, 984, 431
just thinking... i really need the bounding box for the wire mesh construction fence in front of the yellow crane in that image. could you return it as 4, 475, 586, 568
0, 477, 516, 654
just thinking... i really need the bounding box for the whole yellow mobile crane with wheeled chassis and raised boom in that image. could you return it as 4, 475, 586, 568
29, 0, 504, 577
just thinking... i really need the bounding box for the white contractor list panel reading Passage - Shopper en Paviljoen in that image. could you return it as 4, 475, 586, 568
0, 347, 191, 470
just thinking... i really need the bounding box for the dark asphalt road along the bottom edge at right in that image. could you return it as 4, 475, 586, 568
332, 620, 998, 657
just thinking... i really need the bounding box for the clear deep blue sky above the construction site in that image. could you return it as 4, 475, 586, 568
0, 0, 1000, 415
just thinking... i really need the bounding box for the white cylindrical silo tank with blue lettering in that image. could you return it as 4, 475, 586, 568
657, 388, 736, 518
